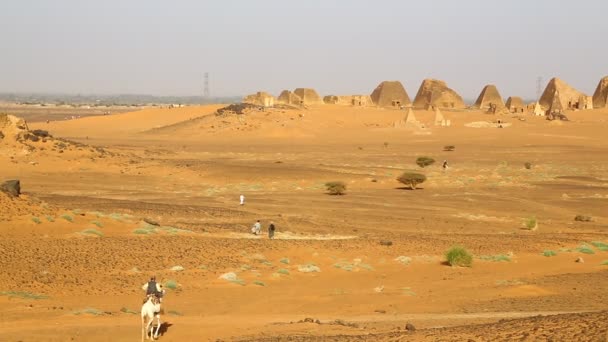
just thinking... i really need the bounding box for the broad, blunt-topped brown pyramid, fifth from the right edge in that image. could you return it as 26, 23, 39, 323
414, 79, 466, 109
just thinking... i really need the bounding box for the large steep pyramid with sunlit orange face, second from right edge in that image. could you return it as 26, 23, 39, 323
538, 77, 586, 111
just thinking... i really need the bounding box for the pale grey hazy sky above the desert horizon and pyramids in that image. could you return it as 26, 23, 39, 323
0, 0, 608, 98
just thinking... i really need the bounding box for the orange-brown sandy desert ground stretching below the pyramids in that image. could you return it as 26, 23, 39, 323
0, 105, 608, 341
